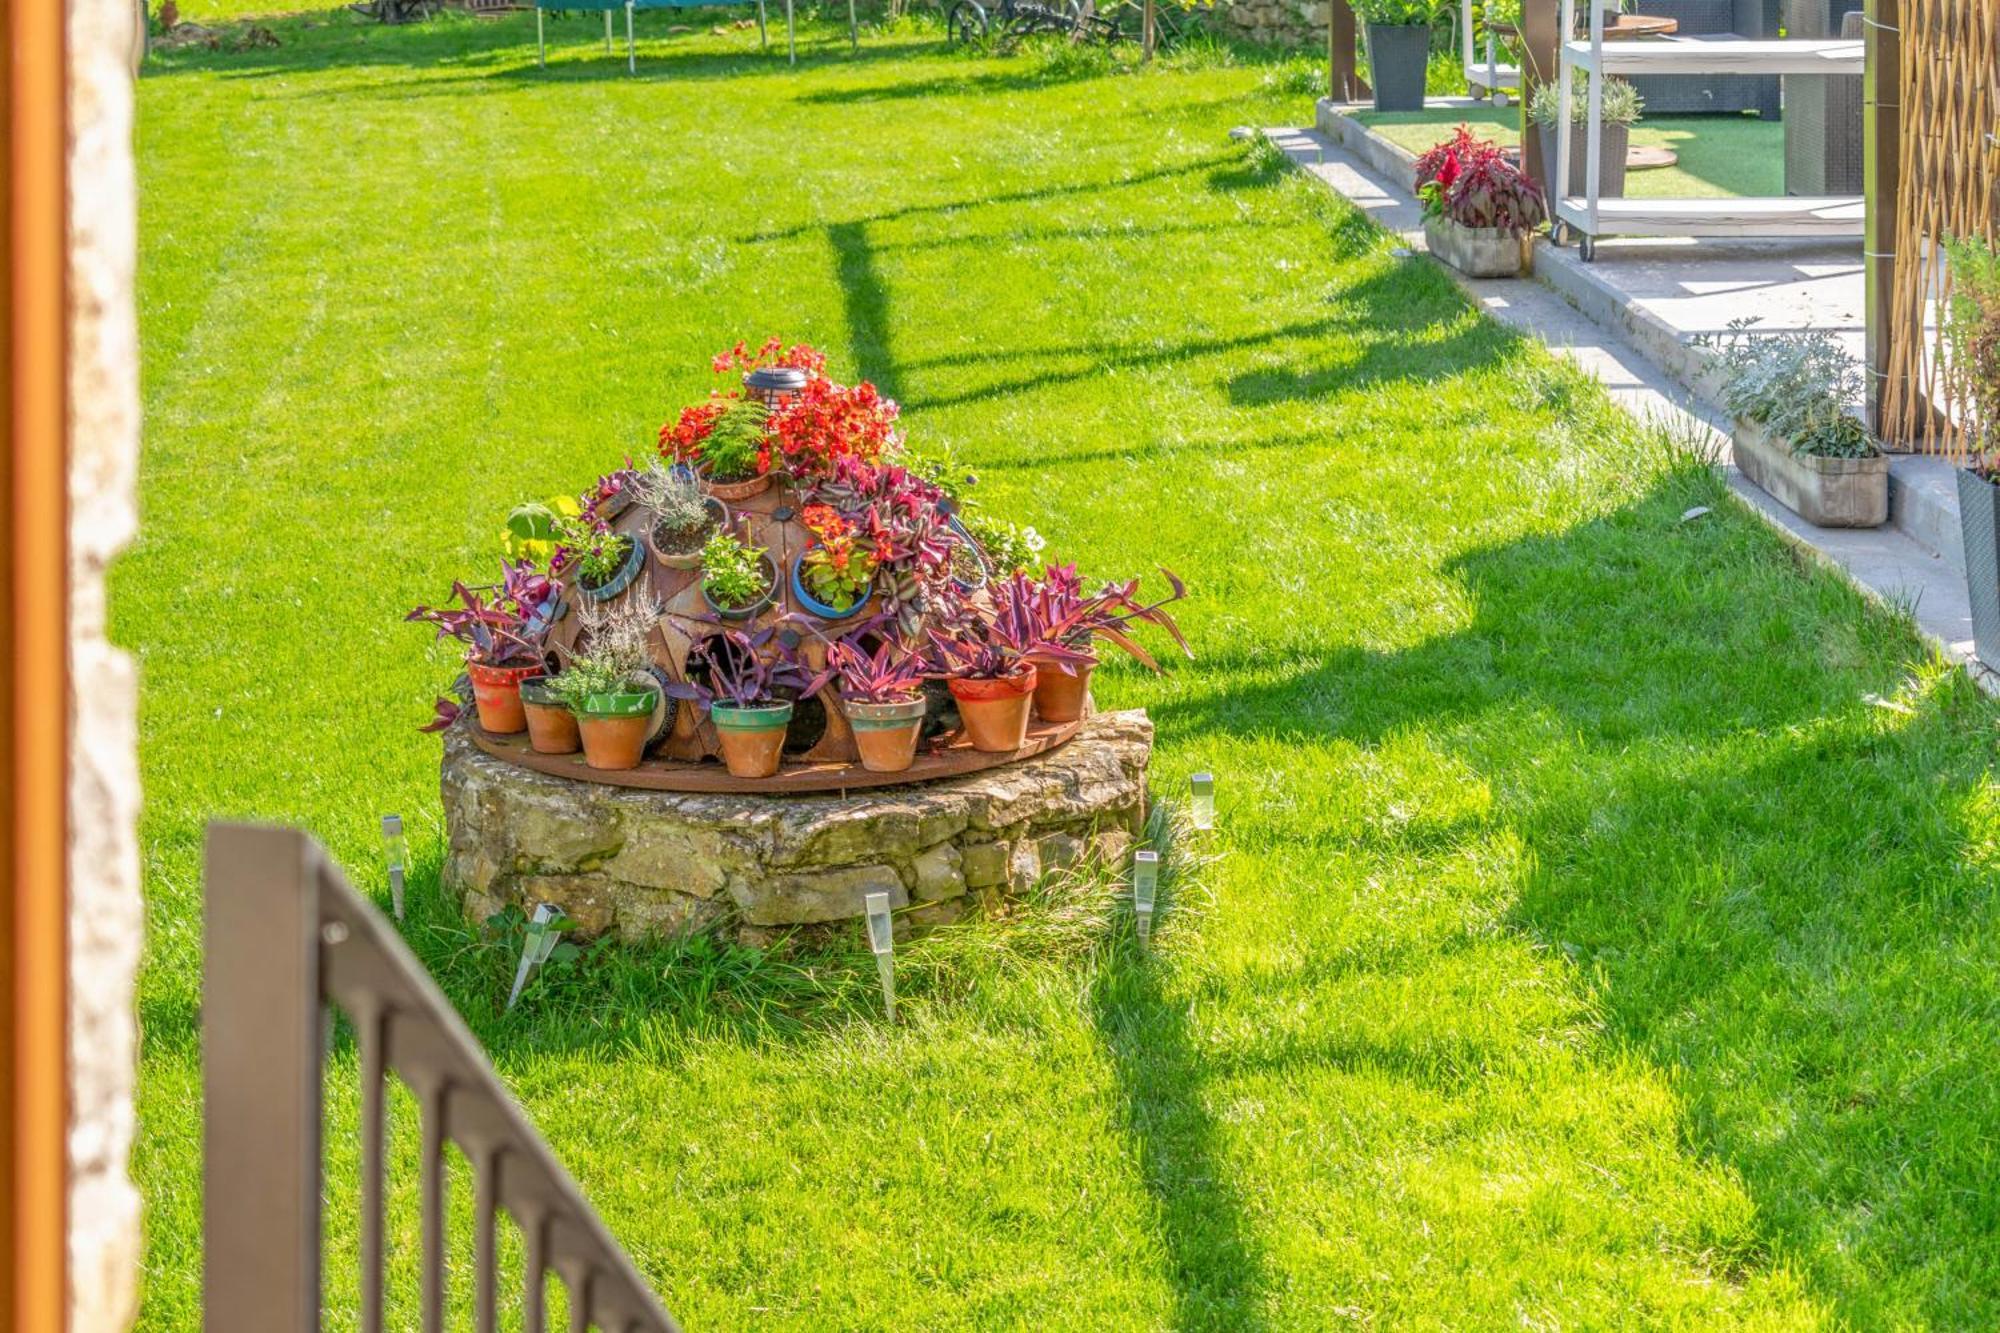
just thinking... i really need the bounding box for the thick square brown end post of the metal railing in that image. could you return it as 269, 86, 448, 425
202, 825, 322, 1333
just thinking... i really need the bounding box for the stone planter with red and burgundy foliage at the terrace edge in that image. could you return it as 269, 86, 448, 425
1416, 126, 1548, 278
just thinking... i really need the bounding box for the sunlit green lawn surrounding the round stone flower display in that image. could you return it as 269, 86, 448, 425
129, 14, 2000, 1329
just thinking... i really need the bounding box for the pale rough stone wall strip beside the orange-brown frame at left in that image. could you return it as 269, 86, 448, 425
68, 0, 144, 1333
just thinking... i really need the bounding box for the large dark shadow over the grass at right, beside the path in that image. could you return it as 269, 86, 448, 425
1154, 470, 2000, 1327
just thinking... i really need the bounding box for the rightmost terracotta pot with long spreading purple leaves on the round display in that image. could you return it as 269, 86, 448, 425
1010, 564, 1194, 723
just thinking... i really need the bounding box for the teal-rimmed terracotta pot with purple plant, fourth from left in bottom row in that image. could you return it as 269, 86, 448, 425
668, 624, 826, 779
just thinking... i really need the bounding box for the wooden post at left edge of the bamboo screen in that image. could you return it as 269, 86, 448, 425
1862, 0, 1896, 442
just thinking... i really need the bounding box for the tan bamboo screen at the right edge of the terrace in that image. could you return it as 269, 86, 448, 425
1882, 0, 2000, 456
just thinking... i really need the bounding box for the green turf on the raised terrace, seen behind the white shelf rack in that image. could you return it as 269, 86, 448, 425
1354, 106, 1784, 198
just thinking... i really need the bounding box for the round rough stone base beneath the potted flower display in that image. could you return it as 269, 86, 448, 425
444, 711, 1152, 941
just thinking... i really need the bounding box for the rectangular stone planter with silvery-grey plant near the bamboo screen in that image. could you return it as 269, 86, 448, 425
1696, 320, 1888, 528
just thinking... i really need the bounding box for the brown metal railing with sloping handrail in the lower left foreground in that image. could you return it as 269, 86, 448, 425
202, 825, 676, 1333
